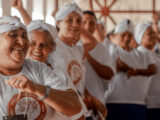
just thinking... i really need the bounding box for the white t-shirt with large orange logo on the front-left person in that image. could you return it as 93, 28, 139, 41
0, 59, 70, 120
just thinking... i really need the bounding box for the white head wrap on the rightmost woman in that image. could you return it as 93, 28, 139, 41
134, 21, 152, 45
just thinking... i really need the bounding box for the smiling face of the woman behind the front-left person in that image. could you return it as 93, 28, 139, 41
27, 30, 53, 63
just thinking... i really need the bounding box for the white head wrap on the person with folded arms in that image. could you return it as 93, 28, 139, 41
114, 19, 134, 34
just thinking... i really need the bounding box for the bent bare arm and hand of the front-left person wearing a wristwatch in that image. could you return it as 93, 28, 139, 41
6, 75, 81, 116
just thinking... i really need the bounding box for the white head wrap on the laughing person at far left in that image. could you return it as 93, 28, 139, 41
0, 16, 26, 34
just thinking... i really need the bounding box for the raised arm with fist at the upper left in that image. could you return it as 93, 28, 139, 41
12, 0, 32, 25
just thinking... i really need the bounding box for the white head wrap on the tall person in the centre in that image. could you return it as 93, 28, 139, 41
56, 2, 82, 21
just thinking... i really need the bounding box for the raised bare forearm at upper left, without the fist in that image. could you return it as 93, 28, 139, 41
18, 8, 32, 25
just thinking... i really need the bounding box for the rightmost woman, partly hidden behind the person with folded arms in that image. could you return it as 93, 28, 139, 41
140, 22, 160, 120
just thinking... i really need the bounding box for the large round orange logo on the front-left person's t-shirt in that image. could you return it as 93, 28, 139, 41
8, 92, 47, 120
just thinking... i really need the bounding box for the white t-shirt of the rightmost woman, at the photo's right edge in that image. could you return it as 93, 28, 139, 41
147, 53, 160, 108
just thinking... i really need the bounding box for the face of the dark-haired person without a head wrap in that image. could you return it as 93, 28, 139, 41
83, 14, 97, 34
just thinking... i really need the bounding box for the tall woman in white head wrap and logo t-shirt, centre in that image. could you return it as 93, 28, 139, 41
54, 3, 106, 117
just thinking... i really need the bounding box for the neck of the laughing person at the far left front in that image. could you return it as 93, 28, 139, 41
0, 65, 22, 76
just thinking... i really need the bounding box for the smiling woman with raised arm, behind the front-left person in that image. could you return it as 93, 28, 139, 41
13, 0, 86, 120
